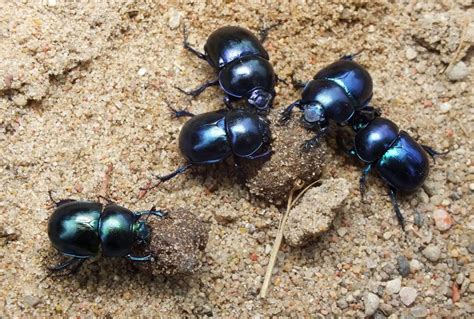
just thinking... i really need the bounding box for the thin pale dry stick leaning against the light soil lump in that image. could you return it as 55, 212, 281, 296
260, 180, 319, 298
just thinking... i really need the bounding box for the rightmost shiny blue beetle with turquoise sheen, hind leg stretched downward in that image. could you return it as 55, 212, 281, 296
338, 117, 447, 229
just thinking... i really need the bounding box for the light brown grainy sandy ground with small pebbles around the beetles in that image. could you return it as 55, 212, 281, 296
0, 0, 474, 318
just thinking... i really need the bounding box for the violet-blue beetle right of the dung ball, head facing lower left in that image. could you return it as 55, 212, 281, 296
280, 53, 380, 151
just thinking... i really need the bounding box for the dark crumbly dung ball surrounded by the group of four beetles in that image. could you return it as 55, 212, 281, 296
243, 112, 327, 205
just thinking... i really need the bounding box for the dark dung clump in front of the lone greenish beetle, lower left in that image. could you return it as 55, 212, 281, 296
133, 210, 209, 275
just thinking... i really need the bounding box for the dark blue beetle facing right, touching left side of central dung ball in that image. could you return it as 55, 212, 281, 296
143, 107, 271, 190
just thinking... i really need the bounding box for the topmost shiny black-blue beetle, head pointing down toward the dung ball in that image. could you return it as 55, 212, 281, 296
177, 25, 277, 114
